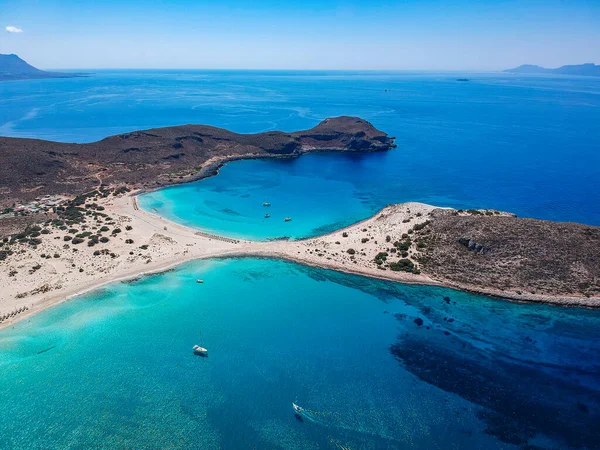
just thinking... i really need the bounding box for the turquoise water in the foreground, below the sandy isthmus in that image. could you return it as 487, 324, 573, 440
0, 259, 600, 449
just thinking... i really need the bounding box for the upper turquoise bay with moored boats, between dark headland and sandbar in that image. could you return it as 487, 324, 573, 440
139, 153, 374, 240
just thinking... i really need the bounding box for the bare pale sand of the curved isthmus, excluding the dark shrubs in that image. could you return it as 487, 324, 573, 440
0, 192, 600, 329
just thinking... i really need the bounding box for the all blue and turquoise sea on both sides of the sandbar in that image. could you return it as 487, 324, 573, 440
0, 71, 600, 449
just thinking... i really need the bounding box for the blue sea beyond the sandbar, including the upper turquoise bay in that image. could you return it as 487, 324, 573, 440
0, 71, 600, 238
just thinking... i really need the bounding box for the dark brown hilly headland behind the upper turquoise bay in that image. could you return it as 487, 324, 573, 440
0, 117, 395, 207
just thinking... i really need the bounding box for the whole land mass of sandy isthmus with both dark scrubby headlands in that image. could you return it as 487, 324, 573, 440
0, 117, 600, 327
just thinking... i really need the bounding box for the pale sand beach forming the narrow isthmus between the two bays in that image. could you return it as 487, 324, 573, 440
0, 195, 600, 328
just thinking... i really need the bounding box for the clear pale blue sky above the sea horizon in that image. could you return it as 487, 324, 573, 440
0, 0, 600, 70
